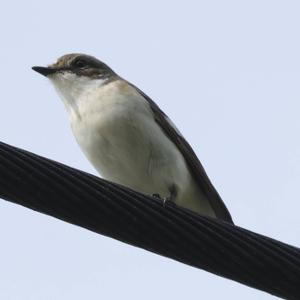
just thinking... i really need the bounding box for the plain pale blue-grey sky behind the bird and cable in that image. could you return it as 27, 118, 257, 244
0, 0, 300, 300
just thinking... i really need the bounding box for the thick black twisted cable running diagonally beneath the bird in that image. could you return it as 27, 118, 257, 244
0, 142, 300, 300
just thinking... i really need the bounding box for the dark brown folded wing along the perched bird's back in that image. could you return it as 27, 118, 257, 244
129, 83, 233, 224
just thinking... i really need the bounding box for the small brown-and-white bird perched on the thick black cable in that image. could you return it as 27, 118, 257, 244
32, 53, 233, 224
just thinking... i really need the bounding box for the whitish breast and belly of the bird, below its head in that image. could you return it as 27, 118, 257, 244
49, 74, 213, 215
